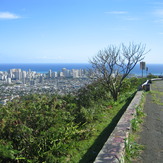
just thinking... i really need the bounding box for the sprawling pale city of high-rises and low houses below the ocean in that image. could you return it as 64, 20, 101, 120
0, 68, 91, 104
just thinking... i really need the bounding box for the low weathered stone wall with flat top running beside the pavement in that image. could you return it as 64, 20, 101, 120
94, 91, 142, 163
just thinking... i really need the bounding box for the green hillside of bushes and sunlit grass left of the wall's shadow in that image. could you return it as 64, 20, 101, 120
0, 78, 144, 163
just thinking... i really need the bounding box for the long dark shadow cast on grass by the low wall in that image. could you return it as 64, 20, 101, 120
79, 92, 136, 163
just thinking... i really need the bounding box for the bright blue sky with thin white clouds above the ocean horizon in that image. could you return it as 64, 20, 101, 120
0, 0, 163, 63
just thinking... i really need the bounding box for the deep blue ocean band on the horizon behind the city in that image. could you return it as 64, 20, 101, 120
0, 63, 163, 76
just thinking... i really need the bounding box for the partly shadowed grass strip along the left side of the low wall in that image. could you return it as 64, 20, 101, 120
70, 91, 134, 163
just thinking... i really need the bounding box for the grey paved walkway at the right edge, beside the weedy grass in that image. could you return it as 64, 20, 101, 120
137, 80, 163, 163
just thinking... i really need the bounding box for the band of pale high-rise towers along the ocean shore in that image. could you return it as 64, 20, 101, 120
0, 68, 87, 85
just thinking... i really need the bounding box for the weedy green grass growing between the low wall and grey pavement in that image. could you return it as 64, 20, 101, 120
125, 80, 163, 163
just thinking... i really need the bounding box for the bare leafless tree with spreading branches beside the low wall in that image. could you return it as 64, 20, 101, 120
90, 43, 149, 101
